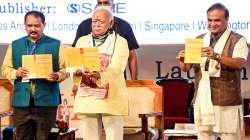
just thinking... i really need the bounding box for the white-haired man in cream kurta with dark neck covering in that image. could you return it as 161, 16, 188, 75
71, 6, 129, 140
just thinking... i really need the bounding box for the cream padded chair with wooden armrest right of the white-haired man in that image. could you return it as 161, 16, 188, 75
102, 80, 163, 140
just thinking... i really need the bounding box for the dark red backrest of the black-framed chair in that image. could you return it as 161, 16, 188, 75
156, 79, 194, 126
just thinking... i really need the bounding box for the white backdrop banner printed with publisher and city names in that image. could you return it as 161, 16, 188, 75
0, 0, 250, 45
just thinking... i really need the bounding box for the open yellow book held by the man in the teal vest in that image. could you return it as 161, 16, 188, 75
22, 54, 53, 79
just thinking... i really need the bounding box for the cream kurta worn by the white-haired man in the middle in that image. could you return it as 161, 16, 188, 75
74, 33, 129, 115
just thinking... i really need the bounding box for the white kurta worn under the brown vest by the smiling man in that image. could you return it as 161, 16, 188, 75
195, 29, 249, 133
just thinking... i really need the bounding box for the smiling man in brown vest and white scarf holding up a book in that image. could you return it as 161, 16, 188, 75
177, 3, 249, 140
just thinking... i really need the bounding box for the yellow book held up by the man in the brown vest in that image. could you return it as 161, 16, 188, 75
184, 39, 203, 64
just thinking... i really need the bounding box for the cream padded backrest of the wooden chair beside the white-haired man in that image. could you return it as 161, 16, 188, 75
123, 80, 163, 127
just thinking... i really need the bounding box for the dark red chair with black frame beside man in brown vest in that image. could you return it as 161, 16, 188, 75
156, 79, 194, 129
